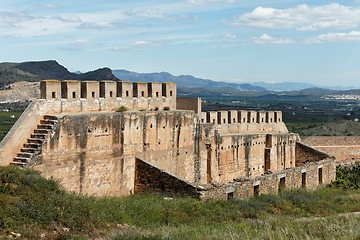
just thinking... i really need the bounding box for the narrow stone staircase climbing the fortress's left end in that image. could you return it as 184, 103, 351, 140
10, 115, 58, 167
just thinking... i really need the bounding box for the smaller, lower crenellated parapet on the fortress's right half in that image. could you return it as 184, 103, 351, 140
199, 110, 288, 134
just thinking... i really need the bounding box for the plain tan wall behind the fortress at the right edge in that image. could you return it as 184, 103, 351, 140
302, 136, 360, 163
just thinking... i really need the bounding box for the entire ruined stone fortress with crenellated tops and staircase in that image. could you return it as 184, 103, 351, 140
0, 80, 335, 200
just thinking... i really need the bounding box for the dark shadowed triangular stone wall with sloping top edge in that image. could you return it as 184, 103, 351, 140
134, 158, 199, 198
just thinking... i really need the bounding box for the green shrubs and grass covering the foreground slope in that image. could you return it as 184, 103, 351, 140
0, 167, 360, 239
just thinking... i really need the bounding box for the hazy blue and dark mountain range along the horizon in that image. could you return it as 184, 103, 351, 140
0, 60, 358, 96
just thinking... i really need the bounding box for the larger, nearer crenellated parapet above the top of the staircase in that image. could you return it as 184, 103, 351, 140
40, 80, 176, 113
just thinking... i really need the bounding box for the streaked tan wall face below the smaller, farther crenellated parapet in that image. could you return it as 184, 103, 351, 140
200, 130, 297, 182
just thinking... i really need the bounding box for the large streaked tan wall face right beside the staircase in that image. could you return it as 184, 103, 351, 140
35, 111, 194, 196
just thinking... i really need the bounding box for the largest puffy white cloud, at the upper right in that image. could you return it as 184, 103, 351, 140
233, 3, 360, 31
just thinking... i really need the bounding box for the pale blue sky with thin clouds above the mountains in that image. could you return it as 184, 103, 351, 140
0, 0, 360, 88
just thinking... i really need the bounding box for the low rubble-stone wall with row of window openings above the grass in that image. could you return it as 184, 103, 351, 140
200, 158, 336, 200
